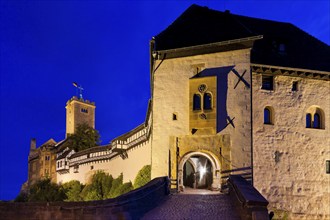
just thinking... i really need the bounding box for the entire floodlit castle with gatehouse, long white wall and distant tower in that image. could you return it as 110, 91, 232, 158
28, 5, 330, 219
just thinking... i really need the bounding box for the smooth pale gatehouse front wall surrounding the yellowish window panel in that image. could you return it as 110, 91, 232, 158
152, 49, 251, 178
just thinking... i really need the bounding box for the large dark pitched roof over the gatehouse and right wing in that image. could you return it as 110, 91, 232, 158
155, 5, 330, 71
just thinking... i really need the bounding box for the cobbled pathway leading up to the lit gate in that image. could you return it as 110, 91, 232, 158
142, 190, 240, 220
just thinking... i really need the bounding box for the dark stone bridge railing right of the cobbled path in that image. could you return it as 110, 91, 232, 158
228, 175, 269, 220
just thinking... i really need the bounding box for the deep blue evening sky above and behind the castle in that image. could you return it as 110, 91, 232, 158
0, 0, 330, 200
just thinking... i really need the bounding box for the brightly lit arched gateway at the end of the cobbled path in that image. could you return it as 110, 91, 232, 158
178, 151, 221, 190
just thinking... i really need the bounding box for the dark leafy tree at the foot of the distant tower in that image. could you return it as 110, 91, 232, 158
65, 123, 100, 152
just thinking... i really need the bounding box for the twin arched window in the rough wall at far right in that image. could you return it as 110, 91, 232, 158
306, 106, 325, 129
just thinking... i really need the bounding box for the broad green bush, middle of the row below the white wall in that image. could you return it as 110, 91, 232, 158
81, 171, 113, 201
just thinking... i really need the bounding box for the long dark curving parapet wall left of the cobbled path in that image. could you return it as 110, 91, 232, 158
0, 177, 169, 220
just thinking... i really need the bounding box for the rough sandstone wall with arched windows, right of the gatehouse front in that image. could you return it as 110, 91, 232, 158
253, 74, 330, 219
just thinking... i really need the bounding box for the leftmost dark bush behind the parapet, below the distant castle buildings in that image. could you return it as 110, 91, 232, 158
28, 178, 67, 202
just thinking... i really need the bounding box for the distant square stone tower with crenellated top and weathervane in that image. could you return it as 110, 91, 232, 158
65, 96, 95, 137
